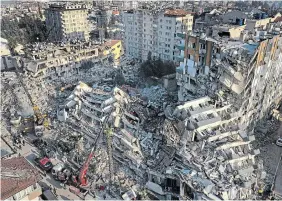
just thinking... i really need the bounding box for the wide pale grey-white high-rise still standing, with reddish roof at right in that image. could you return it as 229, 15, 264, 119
123, 9, 193, 61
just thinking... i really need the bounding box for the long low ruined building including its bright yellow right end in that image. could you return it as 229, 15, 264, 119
17, 40, 123, 79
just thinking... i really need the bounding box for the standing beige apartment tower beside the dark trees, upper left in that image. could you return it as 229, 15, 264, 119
45, 4, 89, 41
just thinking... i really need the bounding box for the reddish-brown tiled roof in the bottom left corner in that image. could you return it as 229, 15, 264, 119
1, 157, 42, 200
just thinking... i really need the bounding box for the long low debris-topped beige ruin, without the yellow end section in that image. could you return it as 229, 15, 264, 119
21, 44, 99, 77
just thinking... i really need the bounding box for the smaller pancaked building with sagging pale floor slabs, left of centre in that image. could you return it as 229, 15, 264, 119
57, 82, 127, 127
